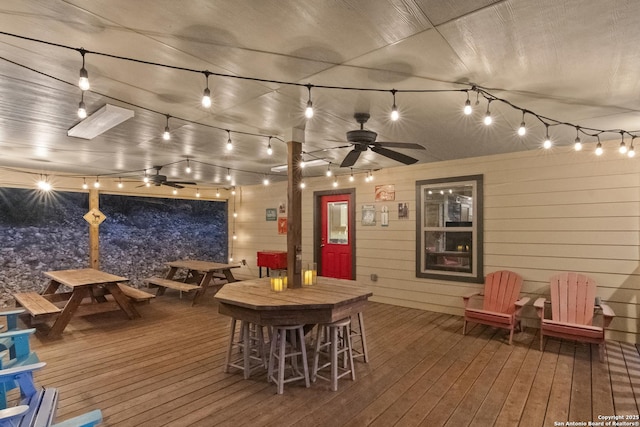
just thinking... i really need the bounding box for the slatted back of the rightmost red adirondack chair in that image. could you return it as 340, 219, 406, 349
549, 273, 596, 325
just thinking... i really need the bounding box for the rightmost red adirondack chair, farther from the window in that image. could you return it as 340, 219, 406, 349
534, 273, 615, 362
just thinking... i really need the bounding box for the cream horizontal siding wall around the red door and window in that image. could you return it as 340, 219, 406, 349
229, 142, 640, 343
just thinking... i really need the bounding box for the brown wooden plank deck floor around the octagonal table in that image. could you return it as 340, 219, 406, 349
21, 292, 640, 427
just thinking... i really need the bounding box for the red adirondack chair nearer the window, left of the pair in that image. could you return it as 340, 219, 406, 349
462, 270, 530, 344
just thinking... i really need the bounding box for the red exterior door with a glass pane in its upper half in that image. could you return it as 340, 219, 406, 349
320, 194, 353, 279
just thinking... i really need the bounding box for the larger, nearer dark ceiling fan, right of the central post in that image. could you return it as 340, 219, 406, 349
340, 113, 425, 168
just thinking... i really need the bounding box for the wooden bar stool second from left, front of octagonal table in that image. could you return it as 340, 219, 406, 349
267, 325, 311, 394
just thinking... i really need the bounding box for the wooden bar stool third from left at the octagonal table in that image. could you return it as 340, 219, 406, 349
312, 318, 356, 391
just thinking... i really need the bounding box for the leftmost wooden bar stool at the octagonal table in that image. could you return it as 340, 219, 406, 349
224, 318, 267, 379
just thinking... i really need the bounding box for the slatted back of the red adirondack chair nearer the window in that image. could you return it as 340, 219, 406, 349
482, 270, 522, 314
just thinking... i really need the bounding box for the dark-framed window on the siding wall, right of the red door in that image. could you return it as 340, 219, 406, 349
416, 175, 484, 283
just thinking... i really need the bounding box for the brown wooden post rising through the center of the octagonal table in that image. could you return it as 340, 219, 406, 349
286, 128, 304, 288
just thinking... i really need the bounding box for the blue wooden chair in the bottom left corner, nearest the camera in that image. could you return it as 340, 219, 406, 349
0, 362, 102, 427
